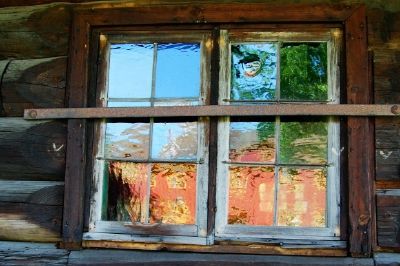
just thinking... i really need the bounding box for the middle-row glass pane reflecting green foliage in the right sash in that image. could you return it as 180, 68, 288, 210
280, 120, 328, 164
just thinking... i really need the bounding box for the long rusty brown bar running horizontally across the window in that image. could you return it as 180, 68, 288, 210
24, 104, 400, 120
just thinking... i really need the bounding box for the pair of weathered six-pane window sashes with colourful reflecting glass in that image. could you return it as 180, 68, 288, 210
84, 28, 341, 245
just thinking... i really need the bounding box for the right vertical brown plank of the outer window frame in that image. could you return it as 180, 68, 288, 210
345, 6, 374, 257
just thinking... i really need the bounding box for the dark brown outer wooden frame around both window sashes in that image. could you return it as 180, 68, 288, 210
62, 3, 375, 257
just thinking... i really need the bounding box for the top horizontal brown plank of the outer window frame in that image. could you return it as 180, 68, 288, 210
74, 3, 354, 26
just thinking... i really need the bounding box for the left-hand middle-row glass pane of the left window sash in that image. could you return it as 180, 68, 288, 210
104, 123, 150, 159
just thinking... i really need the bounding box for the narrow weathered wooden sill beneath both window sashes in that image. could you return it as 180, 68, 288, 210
82, 233, 347, 257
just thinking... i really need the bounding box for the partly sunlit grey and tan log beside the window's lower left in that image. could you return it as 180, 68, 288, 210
0, 181, 64, 242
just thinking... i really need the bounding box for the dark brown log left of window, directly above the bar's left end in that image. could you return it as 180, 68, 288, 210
0, 57, 67, 116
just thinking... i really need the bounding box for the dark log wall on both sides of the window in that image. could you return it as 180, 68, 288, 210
0, 0, 400, 258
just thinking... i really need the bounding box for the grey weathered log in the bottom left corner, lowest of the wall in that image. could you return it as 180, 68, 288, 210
0, 241, 69, 266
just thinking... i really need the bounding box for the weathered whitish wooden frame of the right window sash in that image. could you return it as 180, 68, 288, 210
215, 26, 346, 240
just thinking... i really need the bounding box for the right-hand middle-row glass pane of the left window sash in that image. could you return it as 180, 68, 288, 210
151, 122, 197, 160
